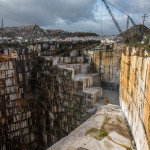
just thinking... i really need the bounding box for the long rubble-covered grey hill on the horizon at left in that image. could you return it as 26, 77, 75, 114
0, 25, 98, 38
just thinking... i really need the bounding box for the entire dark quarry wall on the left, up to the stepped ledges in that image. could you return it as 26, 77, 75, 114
0, 41, 101, 150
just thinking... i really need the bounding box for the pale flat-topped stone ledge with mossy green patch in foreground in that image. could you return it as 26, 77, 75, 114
48, 105, 133, 150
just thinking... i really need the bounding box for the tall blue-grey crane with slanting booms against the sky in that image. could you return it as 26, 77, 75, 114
102, 0, 142, 34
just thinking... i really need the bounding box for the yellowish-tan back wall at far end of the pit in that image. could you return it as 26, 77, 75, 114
93, 49, 121, 91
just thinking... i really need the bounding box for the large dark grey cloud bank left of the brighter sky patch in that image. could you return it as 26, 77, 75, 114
0, 0, 96, 25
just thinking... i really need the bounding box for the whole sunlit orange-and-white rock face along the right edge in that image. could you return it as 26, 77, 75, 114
120, 47, 150, 150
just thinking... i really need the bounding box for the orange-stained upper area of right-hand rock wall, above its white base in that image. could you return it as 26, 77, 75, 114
120, 51, 150, 148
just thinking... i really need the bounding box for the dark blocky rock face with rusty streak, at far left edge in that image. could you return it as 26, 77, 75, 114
0, 48, 38, 150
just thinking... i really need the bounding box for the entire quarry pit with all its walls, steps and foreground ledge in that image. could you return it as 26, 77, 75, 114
0, 41, 150, 150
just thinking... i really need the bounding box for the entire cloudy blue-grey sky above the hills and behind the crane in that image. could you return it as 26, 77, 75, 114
0, 0, 150, 35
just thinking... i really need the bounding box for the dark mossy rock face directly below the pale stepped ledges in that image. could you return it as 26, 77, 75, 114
31, 57, 96, 145
